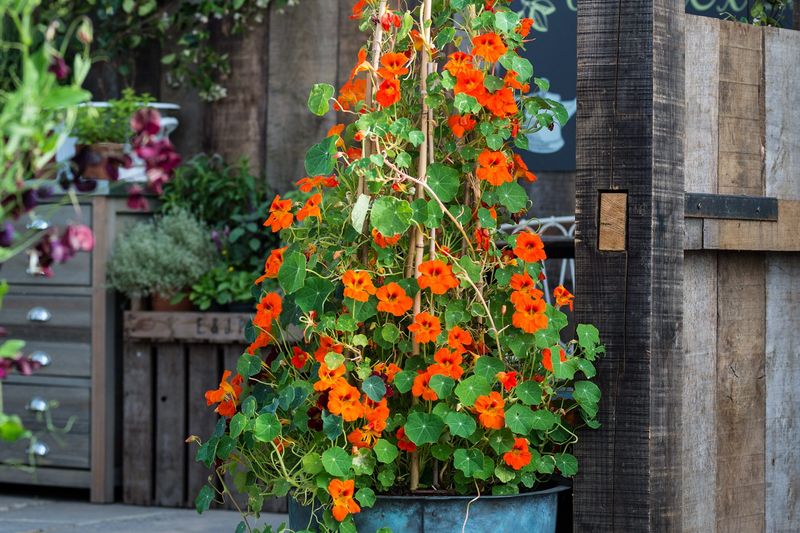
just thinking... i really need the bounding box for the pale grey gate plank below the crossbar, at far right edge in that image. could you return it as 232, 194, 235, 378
765, 254, 800, 533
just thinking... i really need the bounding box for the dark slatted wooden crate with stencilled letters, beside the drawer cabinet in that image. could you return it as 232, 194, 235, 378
122, 312, 286, 512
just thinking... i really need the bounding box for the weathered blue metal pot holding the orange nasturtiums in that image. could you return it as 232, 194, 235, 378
289, 486, 567, 533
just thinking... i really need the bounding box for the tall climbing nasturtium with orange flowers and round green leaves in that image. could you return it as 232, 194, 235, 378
199, 0, 603, 531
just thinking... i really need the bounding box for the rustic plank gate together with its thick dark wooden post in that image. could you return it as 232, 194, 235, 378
574, 0, 800, 532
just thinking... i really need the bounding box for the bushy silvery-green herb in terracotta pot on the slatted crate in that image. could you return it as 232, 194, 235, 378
108, 210, 213, 311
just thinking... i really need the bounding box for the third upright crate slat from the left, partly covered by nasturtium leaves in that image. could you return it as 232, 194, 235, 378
185, 344, 222, 507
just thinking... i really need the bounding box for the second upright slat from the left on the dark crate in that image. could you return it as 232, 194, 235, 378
154, 343, 187, 507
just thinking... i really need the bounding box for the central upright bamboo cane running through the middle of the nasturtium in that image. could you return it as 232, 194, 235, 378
410, 0, 432, 492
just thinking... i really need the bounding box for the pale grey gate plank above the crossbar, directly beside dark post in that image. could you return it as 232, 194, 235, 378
684, 15, 720, 196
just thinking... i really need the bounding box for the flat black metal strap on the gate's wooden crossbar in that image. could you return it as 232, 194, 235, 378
684, 192, 778, 221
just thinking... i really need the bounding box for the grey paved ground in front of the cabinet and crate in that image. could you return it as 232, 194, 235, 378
0, 495, 286, 533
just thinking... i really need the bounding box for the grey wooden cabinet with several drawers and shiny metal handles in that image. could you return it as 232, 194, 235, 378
0, 195, 147, 502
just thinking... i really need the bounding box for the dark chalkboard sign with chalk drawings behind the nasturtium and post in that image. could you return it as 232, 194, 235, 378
511, 0, 792, 171
